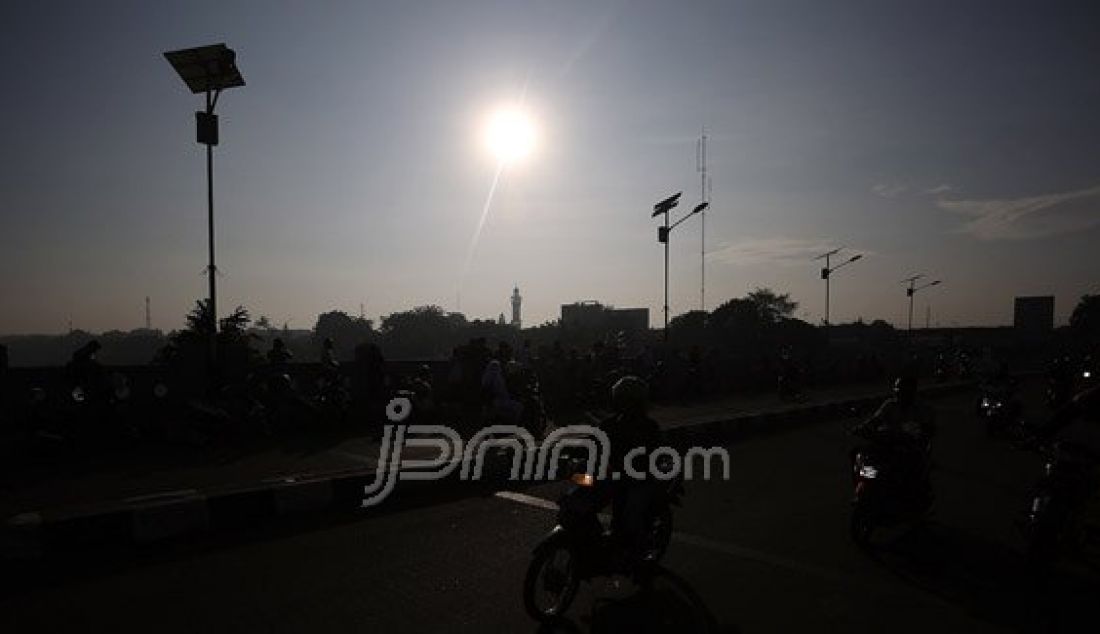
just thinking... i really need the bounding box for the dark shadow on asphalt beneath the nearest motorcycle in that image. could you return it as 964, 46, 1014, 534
538, 569, 740, 634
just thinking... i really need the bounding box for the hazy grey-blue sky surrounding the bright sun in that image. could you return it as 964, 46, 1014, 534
0, 0, 1100, 332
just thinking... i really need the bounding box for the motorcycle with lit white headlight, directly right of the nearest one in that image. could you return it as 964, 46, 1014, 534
849, 435, 933, 547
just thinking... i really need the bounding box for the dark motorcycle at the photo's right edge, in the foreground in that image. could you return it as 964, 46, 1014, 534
1018, 441, 1097, 564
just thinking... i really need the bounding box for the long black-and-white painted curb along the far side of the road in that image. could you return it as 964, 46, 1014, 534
0, 383, 972, 560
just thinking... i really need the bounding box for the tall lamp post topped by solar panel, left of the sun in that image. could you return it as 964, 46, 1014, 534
164, 44, 244, 387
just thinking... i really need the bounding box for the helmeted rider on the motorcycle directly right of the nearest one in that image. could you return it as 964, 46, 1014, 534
853, 374, 936, 502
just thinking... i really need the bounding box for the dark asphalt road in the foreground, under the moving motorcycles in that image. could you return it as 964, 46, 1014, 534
0, 383, 1100, 633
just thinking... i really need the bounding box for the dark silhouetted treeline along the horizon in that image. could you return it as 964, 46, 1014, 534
0, 288, 1100, 367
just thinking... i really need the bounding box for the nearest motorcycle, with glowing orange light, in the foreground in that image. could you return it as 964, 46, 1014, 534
524, 463, 684, 622
